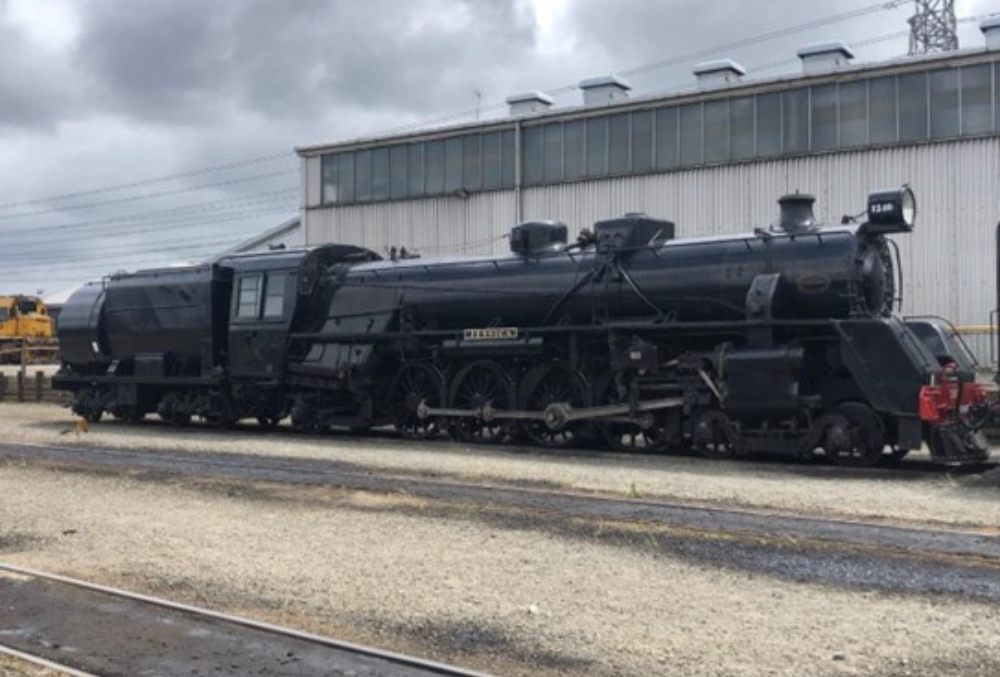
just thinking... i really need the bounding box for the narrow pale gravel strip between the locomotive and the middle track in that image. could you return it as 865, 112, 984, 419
0, 404, 1000, 527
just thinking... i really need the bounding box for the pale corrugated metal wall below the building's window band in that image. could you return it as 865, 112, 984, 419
304, 137, 1000, 357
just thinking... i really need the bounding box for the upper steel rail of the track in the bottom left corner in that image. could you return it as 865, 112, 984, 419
0, 561, 496, 677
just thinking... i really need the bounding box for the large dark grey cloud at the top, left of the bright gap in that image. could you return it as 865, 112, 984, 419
78, 0, 534, 124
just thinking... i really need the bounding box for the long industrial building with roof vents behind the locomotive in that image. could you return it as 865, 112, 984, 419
298, 18, 1000, 358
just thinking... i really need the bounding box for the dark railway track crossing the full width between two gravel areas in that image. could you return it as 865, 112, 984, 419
0, 444, 1000, 601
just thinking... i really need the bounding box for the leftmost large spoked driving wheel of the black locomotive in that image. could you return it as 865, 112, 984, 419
388, 362, 445, 440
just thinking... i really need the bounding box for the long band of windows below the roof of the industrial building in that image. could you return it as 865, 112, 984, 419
322, 58, 1000, 204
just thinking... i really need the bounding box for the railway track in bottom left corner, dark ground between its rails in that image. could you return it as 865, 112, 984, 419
0, 562, 500, 677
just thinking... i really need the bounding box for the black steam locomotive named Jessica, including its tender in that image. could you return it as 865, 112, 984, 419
54, 188, 989, 465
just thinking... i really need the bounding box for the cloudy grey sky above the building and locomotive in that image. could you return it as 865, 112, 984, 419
0, 0, 1000, 294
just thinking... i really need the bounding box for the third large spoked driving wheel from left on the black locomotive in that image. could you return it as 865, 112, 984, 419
518, 362, 587, 449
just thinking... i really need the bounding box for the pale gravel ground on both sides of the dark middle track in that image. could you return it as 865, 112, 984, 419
0, 405, 1000, 677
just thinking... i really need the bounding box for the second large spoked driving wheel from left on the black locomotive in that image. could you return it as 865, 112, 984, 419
449, 360, 514, 444
